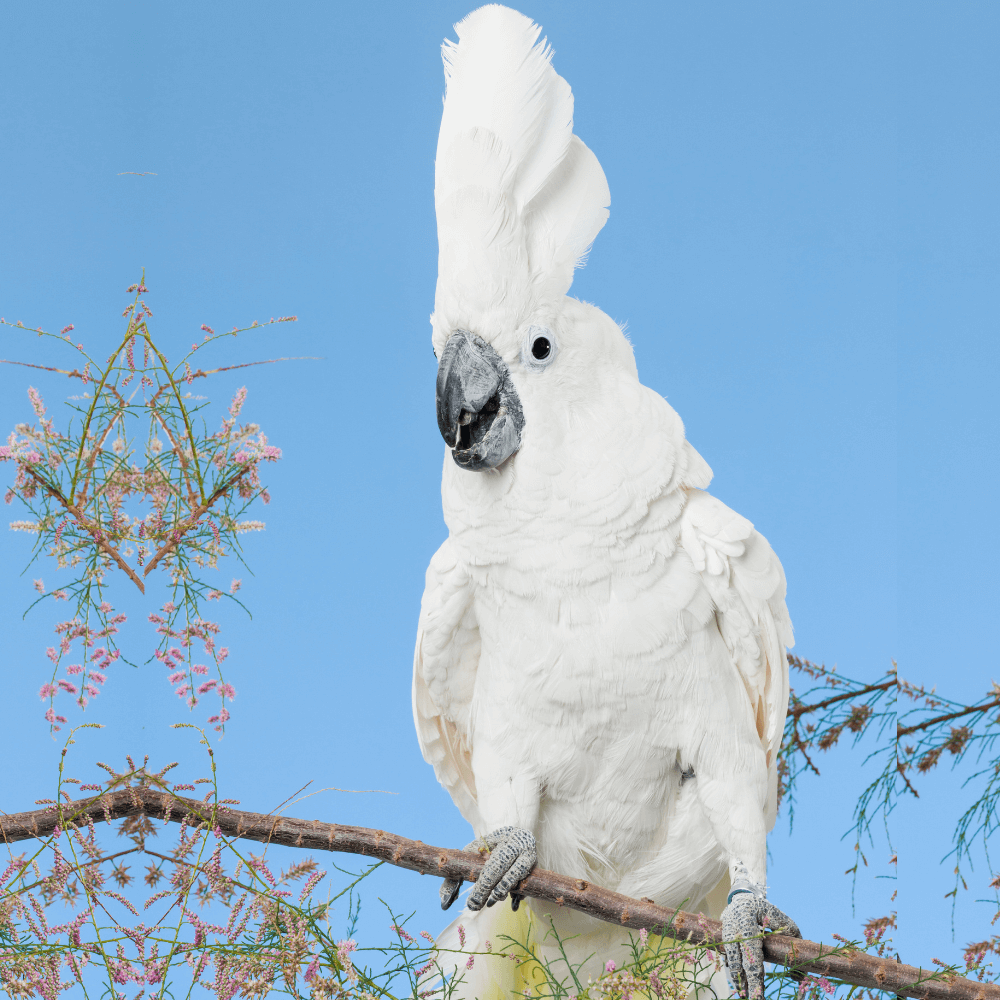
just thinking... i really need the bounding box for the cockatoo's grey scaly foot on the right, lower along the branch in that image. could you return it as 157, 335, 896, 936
722, 877, 802, 1000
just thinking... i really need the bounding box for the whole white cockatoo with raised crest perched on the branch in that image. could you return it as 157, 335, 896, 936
413, 4, 798, 998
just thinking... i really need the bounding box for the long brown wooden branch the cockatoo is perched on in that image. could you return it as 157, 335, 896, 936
0, 787, 1000, 1000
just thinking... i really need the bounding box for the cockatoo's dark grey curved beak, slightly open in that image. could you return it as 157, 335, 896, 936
437, 330, 524, 469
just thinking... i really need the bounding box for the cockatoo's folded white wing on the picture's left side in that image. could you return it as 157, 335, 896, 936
413, 541, 479, 829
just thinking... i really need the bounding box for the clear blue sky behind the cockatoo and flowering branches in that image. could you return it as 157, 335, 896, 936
0, 0, 1000, 984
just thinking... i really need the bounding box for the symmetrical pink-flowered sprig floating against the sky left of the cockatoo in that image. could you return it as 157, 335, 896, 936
0, 282, 295, 731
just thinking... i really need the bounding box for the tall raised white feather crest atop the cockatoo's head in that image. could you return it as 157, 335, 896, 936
432, 4, 611, 357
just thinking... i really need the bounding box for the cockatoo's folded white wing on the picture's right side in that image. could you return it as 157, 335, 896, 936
681, 490, 793, 829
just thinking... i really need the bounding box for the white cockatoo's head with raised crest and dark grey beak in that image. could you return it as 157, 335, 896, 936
431, 4, 616, 471
